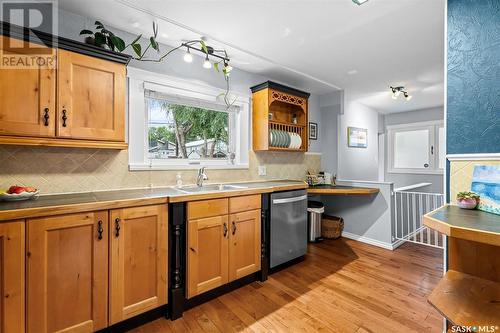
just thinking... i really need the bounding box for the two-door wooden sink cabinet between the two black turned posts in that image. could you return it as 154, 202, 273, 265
186, 195, 261, 298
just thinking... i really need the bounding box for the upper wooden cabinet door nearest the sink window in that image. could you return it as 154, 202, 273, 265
57, 49, 125, 141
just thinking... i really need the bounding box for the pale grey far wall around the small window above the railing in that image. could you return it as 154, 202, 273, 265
384, 107, 444, 193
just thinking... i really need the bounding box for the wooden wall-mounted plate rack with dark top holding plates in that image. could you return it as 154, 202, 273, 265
250, 81, 310, 152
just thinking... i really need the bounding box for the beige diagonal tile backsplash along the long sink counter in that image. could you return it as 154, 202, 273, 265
0, 146, 321, 194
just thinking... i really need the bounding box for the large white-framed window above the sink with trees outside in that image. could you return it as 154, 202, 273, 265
129, 70, 249, 170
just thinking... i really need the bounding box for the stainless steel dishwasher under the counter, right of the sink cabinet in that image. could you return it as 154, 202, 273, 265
270, 190, 307, 268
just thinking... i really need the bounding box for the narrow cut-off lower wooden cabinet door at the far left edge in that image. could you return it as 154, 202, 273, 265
0, 221, 25, 333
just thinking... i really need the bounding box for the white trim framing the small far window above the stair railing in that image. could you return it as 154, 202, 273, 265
387, 120, 444, 175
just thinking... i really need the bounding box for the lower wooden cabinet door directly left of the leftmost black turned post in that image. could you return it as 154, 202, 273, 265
109, 205, 168, 324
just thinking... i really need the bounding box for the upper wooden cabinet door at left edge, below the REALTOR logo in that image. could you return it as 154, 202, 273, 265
0, 37, 56, 137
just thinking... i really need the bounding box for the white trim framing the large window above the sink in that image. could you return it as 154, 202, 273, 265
127, 67, 250, 171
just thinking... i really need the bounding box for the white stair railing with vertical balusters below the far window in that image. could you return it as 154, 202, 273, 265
394, 189, 444, 248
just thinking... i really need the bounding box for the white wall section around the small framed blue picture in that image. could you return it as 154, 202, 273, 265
338, 96, 379, 181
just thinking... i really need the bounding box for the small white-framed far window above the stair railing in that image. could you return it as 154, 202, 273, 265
387, 122, 446, 174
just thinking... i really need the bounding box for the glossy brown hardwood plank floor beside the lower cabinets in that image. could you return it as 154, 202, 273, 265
128, 239, 442, 333
